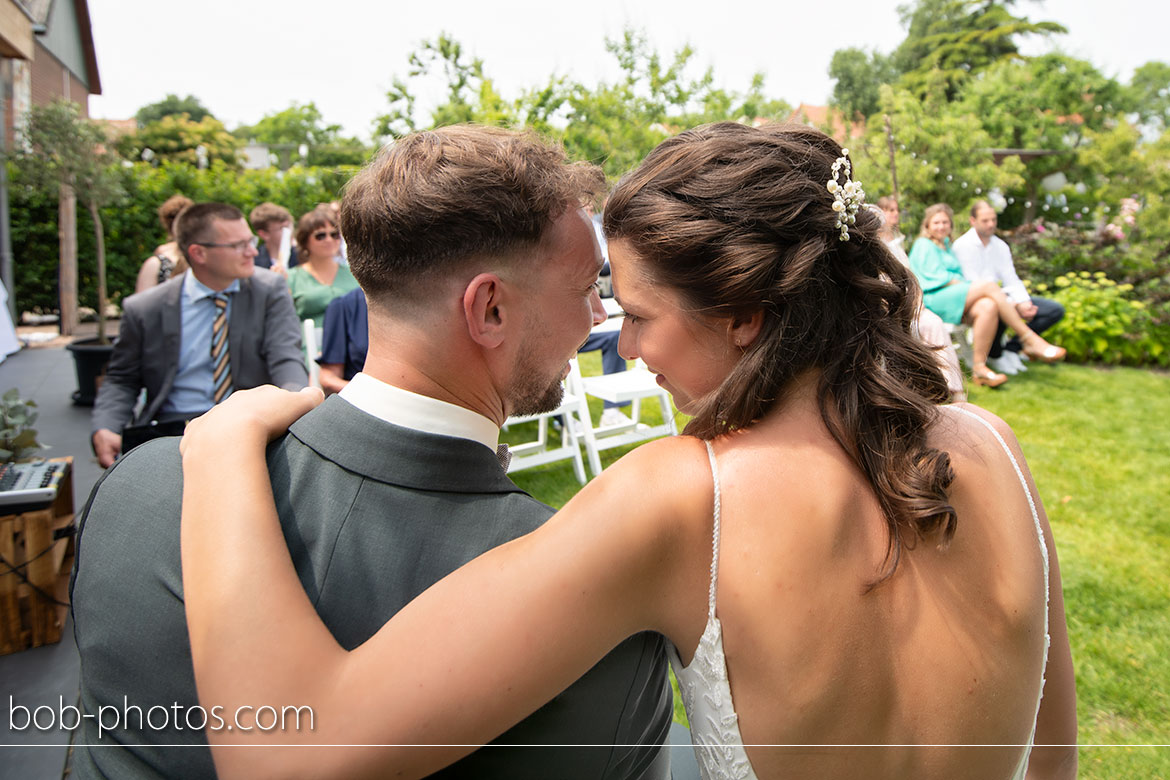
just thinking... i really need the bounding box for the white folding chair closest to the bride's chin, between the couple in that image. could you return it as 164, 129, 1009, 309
581, 359, 679, 476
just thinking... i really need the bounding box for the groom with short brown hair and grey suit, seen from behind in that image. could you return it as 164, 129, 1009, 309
71, 126, 670, 779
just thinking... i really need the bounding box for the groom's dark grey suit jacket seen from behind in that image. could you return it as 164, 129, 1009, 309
70, 398, 670, 779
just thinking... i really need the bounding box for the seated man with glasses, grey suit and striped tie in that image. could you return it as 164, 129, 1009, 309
91, 203, 309, 468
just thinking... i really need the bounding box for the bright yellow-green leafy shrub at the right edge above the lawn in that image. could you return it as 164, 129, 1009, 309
1034, 271, 1170, 366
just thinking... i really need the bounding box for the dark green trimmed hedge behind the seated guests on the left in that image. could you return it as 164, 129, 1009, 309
8, 163, 358, 311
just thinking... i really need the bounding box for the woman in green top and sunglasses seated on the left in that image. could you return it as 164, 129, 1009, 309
289, 206, 358, 327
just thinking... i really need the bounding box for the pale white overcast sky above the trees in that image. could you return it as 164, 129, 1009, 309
89, 0, 1170, 139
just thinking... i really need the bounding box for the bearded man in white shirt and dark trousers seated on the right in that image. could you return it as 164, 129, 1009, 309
952, 200, 1065, 374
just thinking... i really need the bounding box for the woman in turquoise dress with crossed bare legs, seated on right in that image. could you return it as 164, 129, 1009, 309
910, 203, 1065, 387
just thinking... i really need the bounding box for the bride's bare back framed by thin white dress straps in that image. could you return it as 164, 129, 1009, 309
659, 398, 1067, 778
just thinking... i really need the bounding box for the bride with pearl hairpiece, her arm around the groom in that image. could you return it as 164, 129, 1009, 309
183, 123, 1076, 780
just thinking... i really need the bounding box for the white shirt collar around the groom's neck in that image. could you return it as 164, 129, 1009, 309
338, 373, 500, 453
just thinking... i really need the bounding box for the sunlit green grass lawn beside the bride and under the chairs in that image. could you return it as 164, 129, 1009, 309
505, 353, 1170, 780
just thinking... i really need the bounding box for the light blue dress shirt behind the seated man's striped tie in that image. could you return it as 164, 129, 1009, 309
159, 270, 240, 416
